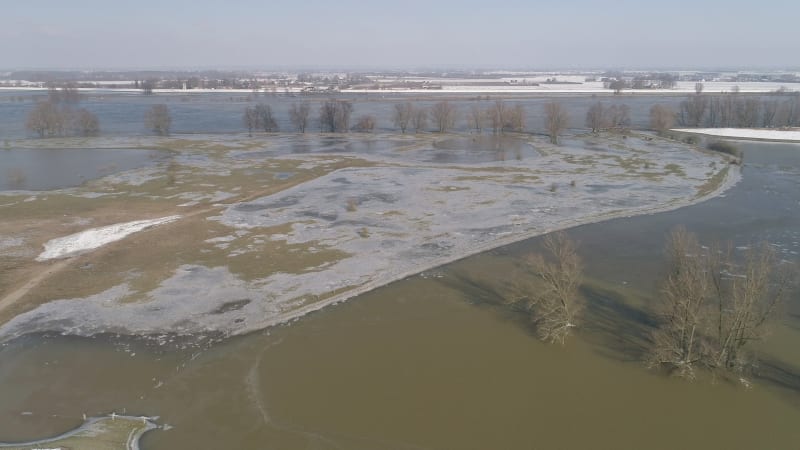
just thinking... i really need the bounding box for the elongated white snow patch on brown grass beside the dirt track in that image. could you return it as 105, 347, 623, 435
36, 216, 181, 261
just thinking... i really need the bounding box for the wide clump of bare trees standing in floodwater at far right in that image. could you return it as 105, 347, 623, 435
650, 228, 792, 378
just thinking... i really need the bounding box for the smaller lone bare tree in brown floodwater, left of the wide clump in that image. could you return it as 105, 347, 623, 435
526, 231, 583, 344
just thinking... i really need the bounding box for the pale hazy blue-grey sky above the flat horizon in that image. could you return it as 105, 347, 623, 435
0, 0, 800, 69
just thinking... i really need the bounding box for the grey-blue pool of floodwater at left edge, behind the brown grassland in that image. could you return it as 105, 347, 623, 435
0, 148, 166, 191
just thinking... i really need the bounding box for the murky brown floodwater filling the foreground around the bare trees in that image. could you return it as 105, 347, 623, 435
0, 143, 800, 449
